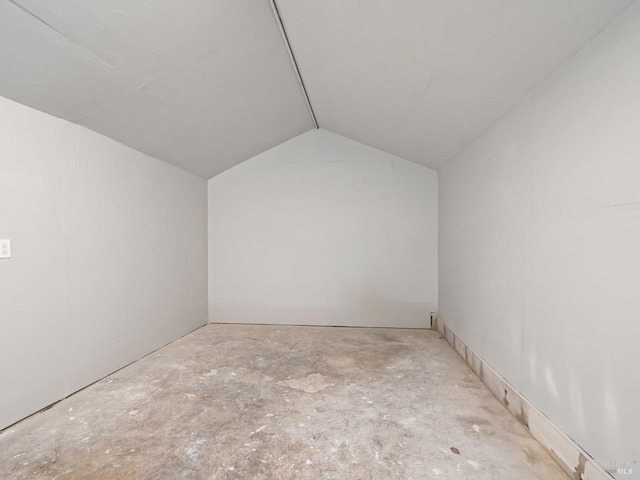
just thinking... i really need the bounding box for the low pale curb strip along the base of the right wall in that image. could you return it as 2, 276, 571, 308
432, 315, 614, 480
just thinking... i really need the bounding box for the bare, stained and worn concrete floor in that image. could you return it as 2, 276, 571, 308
0, 325, 568, 480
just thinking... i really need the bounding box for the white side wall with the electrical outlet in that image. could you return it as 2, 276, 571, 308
0, 98, 207, 428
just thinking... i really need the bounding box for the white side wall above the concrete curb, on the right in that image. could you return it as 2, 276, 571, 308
438, 3, 640, 478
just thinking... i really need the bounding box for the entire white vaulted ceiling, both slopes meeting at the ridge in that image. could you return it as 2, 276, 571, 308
0, 0, 633, 178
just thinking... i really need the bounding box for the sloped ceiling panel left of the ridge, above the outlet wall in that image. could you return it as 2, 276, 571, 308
0, 0, 313, 178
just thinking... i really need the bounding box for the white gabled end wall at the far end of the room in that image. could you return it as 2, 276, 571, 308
208, 130, 437, 328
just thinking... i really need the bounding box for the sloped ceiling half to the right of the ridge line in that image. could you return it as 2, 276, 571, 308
278, 0, 633, 169
